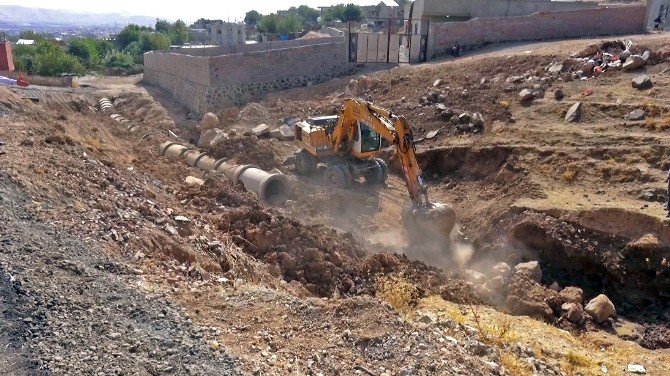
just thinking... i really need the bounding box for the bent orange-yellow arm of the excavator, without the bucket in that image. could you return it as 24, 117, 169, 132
331, 99, 430, 206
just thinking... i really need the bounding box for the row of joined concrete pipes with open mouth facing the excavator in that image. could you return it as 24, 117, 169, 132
160, 142, 289, 205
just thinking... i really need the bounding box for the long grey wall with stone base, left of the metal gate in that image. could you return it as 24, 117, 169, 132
143, 38, 349, 114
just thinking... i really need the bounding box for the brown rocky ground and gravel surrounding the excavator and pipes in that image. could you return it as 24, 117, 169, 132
0, 35, 670, 376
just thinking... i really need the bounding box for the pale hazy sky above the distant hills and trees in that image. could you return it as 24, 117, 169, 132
7, 0, 355, 21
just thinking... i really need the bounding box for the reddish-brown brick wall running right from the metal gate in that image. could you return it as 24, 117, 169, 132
428, 5, 646, 57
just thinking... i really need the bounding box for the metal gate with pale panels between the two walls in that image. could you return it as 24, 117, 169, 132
349, 19, 428, 63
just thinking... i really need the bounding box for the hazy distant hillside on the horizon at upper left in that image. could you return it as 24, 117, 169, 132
0, 5, 156, 26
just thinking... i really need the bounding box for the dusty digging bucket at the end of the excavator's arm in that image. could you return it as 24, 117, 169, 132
402, 203, 456, 266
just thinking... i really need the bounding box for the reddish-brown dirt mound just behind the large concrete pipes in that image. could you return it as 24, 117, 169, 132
209, 136, 281, 170
